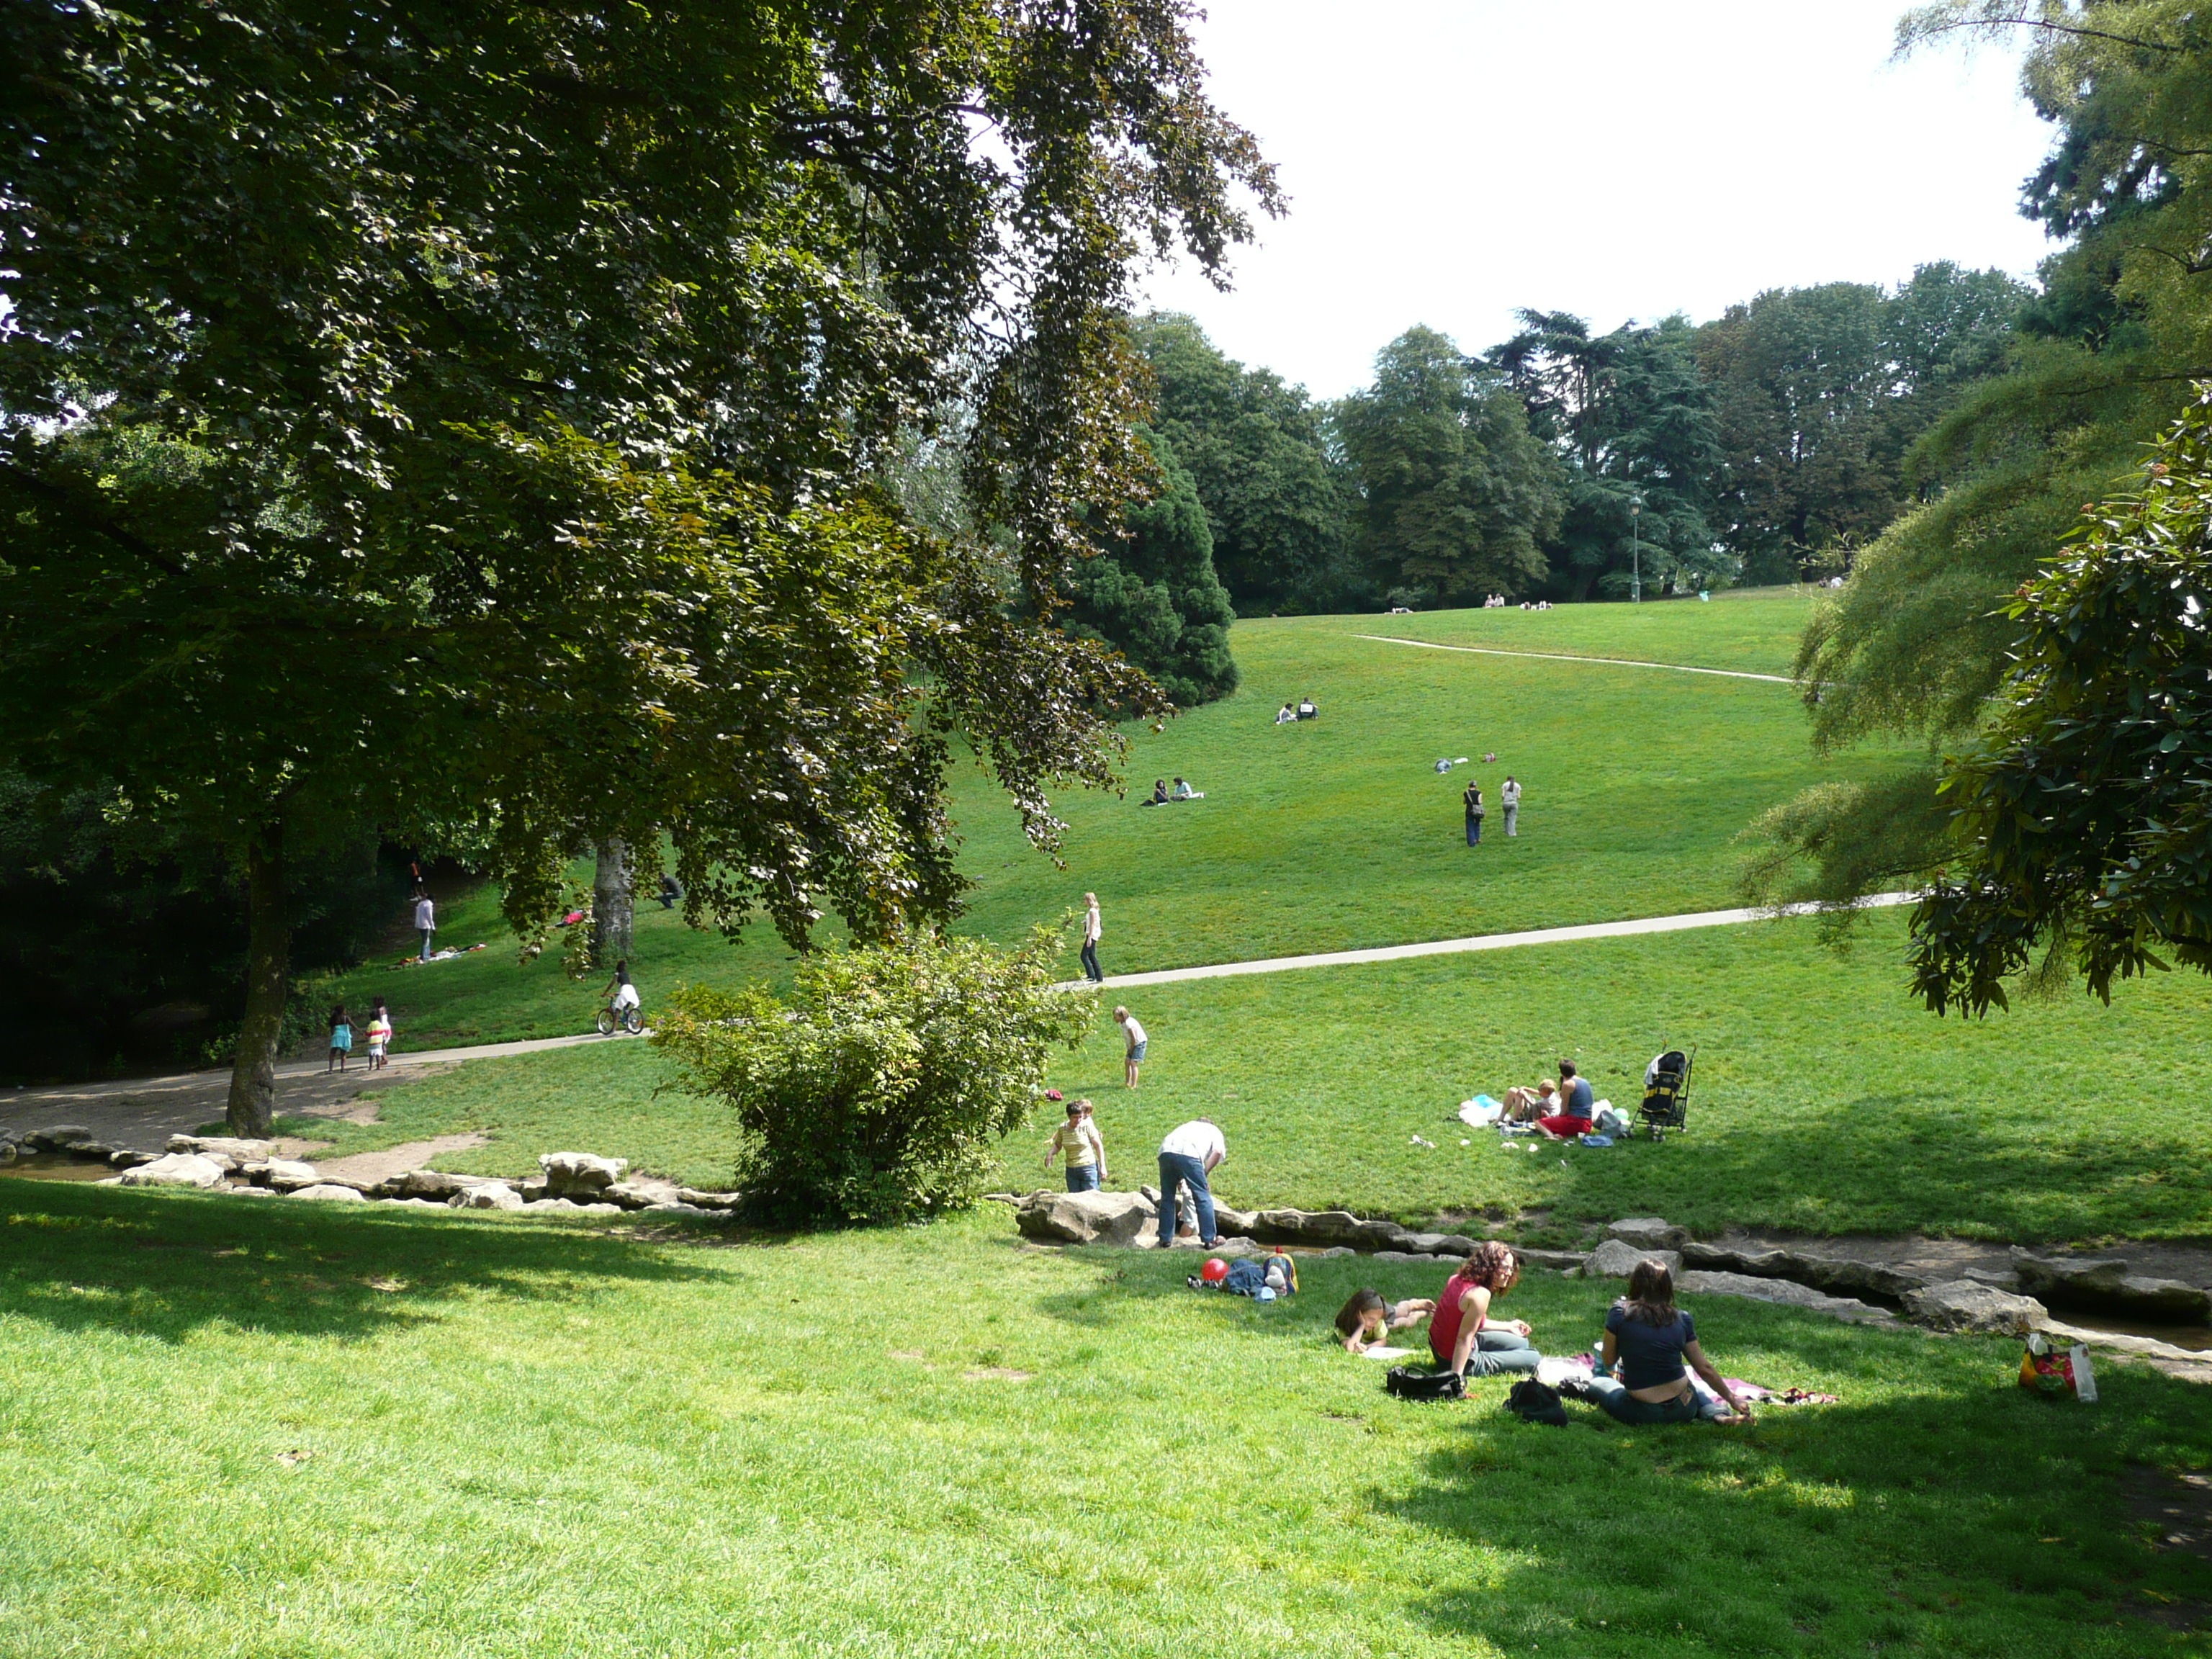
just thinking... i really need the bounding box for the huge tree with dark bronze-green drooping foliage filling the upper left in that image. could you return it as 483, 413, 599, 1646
0, 0, 1277, 1130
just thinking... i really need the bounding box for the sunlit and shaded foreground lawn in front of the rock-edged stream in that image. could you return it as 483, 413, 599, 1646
0, 1181, 2212, 1659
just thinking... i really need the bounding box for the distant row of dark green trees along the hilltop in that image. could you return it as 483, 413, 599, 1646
1132, 264, 2035, 619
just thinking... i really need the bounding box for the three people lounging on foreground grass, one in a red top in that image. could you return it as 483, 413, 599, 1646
1336, 1238, 1752, 1422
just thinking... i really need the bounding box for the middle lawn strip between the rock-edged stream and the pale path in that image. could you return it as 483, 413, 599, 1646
316, 912, 2212, 1243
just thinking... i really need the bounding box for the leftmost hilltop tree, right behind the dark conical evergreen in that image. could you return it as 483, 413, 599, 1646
1130, 312, 1356, 617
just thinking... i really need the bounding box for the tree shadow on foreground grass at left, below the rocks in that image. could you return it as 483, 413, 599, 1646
0, 1181, 712, 1343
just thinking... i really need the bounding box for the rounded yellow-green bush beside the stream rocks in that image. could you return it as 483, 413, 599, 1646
652, 927, 1097, 1226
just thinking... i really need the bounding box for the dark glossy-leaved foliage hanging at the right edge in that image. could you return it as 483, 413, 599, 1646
1913, 395, 2212, 1013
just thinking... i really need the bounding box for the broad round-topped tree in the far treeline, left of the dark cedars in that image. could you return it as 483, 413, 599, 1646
1336, 328, 1562, 604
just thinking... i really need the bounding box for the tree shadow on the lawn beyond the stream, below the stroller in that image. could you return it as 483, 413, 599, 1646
1555, 1095, 2212, 1243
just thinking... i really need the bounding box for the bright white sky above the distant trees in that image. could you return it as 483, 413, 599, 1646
1146, 0, 2051, 398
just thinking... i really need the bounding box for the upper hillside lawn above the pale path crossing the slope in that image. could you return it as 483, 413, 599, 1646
338, 600, 1896, 1048
